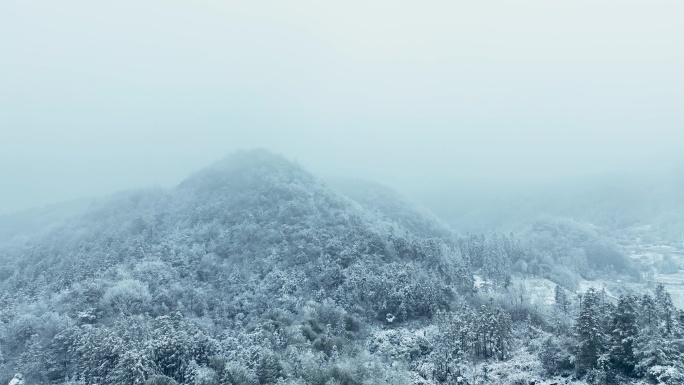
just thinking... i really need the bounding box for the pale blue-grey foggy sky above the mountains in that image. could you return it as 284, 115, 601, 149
0, 0, 684, 213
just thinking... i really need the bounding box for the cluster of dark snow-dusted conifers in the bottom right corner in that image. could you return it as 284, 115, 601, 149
564, 286, 684, 384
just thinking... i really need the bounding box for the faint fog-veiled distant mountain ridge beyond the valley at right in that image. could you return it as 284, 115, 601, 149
420, 166, 684, 243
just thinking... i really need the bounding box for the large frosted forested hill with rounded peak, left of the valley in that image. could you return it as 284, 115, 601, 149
0, 151, 465, 384
